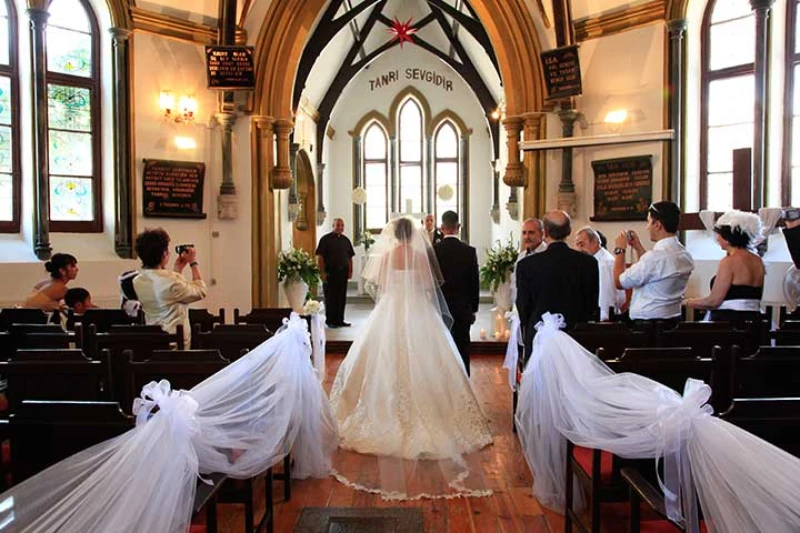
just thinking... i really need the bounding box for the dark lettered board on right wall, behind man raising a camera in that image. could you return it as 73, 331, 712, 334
589, 155, 653, 222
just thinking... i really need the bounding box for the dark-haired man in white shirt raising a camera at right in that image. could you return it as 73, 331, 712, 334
614, 201, 694, 326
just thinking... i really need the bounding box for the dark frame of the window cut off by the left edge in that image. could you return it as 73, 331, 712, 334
0, 0, 22, 233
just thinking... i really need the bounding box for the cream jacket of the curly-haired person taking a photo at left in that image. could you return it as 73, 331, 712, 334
133, 268, 208, 344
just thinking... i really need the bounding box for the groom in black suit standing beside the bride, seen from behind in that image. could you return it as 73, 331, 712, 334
434, 211, 480, 375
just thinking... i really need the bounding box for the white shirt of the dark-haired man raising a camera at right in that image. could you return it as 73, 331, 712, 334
619, 237, 694, 320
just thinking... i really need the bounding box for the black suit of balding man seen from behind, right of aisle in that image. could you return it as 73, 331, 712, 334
516, 241, 600, 358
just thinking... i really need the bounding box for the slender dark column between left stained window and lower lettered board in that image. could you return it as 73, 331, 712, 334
110, 28, 134, 259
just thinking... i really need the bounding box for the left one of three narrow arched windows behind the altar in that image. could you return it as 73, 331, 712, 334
364, 122, 389, 230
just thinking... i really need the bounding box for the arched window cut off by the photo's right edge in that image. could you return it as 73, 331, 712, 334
781, 0, 800, 205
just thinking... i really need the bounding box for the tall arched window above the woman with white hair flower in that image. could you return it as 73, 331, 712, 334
700, 0, 756, 211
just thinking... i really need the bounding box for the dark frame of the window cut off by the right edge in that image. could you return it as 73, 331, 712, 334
781, 0, 800, 206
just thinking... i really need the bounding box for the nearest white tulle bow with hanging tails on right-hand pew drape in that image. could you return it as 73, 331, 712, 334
656, 379, 714, 532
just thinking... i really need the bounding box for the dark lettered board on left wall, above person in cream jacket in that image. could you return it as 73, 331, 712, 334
142, 159, 206, 218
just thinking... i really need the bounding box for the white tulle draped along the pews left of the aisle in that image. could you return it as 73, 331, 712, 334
0, 313, 338, 533
